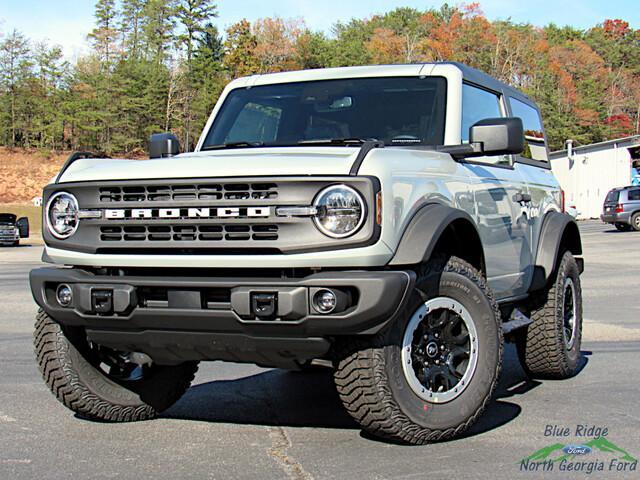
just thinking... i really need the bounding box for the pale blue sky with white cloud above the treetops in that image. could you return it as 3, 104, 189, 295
0, 0, 640, 60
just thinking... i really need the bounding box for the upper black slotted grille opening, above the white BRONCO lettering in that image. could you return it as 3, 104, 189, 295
99, 183, 278, 203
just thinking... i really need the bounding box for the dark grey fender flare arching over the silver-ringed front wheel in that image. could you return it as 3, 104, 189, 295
389, 203, 484, 270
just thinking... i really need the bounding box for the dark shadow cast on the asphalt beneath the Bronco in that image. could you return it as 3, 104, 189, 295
163, 345, 590, 438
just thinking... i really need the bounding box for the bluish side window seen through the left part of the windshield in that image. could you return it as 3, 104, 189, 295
224, 102, 282, 143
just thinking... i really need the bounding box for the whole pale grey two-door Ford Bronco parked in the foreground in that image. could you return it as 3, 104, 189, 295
30, 63, 583, 444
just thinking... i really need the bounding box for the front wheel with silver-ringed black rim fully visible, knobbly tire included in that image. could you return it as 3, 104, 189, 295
335, 258, 503, 444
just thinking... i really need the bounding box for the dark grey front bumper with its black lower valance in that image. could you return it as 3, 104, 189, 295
30, 268, 415, 366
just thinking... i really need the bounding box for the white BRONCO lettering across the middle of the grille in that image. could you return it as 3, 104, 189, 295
104, 207, 271, 220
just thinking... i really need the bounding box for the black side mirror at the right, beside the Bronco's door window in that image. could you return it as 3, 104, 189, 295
469, 117, 524, 156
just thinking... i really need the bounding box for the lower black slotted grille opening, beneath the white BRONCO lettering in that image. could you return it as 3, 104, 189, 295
100, 224, 278, 242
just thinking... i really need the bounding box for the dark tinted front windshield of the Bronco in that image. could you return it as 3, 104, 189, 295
202, 77, 446, 149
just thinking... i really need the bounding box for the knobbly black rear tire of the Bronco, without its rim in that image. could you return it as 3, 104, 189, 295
516, 251, 582, 379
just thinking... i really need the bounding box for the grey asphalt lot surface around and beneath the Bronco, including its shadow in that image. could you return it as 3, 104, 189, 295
0, 222, 640, 480
